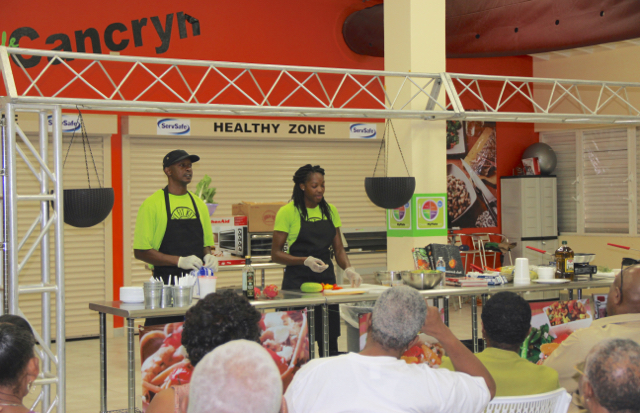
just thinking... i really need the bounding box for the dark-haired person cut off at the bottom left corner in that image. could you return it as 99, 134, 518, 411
0, 322, 40, 413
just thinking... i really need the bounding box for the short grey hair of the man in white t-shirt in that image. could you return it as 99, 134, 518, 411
371, 286, 427, 350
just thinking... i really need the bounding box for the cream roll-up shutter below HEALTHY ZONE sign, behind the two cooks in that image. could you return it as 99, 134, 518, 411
123, 136, 386, 287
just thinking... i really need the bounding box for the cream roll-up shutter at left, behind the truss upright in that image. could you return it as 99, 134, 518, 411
17, 134, 107, 338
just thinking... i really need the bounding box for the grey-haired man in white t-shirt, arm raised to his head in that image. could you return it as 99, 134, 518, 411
285, 286, 495, 413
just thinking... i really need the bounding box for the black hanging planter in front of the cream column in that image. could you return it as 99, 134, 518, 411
364, 119, 416, 209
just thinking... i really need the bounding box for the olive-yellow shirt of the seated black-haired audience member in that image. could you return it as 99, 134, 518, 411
440, 347, 560, 397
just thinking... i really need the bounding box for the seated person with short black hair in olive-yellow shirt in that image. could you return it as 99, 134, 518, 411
440, 291, 560, 397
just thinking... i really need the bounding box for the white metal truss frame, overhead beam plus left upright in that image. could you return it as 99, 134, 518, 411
0, 46, 640, 412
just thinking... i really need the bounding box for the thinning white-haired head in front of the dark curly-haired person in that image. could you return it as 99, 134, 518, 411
188, 340, 282, 413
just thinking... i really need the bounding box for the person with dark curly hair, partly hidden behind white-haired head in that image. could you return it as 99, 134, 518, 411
147, 290, 260, 413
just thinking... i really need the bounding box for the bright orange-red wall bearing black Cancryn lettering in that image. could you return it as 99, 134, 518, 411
0, 0, 538, 318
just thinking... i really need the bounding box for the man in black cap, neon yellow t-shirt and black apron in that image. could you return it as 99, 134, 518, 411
133, 149, 218, 324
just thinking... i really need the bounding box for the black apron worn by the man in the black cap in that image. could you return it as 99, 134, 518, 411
145, 187, 204, 325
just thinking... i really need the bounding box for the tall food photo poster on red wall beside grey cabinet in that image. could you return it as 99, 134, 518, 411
447, 121, 498, 228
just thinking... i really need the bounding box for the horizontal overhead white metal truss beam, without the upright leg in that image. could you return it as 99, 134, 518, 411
0, 46, 640, 124
